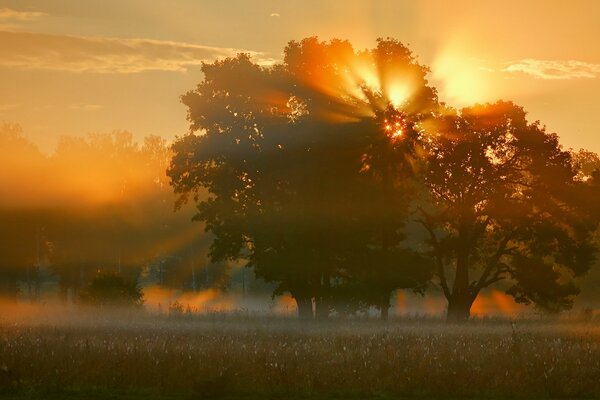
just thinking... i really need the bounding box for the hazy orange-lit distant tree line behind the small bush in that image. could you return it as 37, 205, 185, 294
0, 124, 227, 305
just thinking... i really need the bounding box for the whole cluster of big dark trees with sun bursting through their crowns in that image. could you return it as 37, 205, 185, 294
168, 38, 600, 321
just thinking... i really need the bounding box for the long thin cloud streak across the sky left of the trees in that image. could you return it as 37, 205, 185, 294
0, 31, 269, 73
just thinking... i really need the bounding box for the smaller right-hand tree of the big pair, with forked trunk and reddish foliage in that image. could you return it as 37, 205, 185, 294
420, 102, 600, 321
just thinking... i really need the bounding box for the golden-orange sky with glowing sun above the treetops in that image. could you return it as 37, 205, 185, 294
0, 0, 600, 152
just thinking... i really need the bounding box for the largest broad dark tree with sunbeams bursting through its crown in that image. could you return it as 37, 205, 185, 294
169, 38, 437, 317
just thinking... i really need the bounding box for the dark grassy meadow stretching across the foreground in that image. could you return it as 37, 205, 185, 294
0, 317, 600, 399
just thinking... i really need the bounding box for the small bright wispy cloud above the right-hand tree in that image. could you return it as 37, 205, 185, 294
503, 58, 600, 80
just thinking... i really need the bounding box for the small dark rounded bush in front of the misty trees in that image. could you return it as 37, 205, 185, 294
80, 272, 144, 307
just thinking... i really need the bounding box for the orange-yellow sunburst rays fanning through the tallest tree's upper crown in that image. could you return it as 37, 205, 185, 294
267, 42, 426, 127
